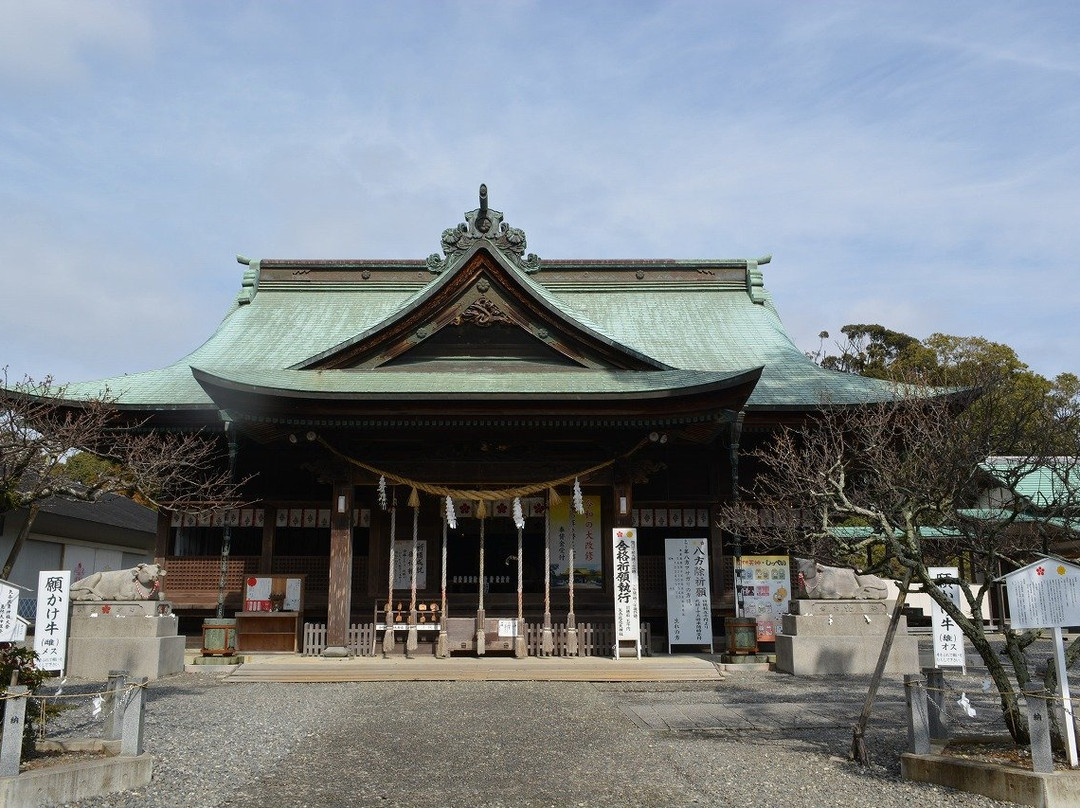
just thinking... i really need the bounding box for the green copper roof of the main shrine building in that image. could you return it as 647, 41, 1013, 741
59, 191, 891, 412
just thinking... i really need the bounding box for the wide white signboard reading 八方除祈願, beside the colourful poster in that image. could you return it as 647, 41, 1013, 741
664, 539, 713, 654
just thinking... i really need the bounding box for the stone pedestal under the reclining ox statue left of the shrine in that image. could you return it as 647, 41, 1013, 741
66, 601, 185, 681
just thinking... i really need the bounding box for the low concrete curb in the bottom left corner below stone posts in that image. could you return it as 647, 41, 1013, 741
0, 753, 153, 808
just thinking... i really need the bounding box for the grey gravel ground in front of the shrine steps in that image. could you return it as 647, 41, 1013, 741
38, 661, 1023, 808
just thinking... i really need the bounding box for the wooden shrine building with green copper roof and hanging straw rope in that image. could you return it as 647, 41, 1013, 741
52, 186, 890, 652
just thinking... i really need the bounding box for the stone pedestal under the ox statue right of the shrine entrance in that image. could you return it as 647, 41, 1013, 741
777, 600, 919, 675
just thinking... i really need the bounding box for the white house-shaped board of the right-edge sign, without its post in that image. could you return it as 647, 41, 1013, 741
1004, 558, 1080, 629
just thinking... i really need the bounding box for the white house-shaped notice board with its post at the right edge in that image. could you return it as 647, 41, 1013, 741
1004, 558, 1080, 768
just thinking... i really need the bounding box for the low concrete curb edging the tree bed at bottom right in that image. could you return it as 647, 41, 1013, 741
900, 752, 1080, 808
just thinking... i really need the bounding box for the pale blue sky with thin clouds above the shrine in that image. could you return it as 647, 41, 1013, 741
0, 0, 1080, 381
